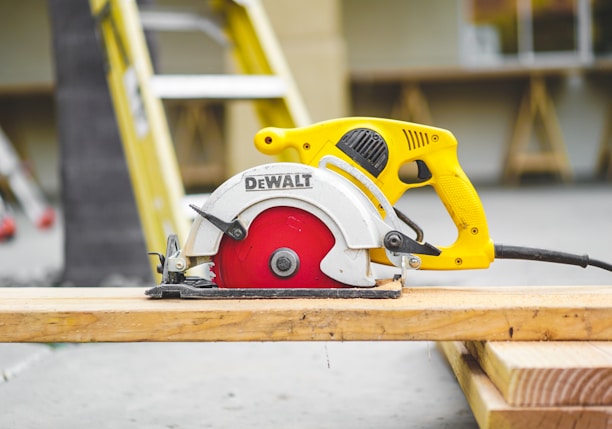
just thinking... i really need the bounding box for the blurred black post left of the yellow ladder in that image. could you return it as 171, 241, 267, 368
48, 0, 152, 286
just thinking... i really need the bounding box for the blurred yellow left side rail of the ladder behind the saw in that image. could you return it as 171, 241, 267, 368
90, 0, 188, 273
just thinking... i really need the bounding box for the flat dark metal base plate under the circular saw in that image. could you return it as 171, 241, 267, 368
145, 280, 402, 299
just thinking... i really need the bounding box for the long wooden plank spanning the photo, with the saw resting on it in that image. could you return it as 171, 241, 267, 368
0, 286, 612, 342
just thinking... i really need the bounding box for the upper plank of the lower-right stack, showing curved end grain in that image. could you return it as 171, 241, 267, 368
466, 341, 612, 406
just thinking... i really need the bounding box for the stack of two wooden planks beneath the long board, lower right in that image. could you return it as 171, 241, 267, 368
438, 341, 612, 429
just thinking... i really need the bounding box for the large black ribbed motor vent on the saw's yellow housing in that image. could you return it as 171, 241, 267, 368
336, 128, 389, 177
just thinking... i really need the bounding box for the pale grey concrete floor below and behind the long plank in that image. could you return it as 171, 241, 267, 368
0, 184, 612, 429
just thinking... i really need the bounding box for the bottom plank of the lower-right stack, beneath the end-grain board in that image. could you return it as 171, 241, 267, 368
438, 341, 612, 429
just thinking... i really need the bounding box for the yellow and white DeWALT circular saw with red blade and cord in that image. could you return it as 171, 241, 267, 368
146, 117, 612, 298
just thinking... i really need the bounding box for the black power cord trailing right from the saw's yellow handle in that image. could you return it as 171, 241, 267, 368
495, 244, 612, 271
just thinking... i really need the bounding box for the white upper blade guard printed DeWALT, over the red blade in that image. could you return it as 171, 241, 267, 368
182, 163, 391, 287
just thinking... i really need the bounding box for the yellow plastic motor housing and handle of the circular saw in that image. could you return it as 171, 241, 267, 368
255, 117, 494, 270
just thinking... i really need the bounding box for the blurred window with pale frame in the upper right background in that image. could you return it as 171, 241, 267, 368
460, 0, 612, 65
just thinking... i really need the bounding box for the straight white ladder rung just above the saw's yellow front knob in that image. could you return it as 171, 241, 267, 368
151, 74, 285, 100
